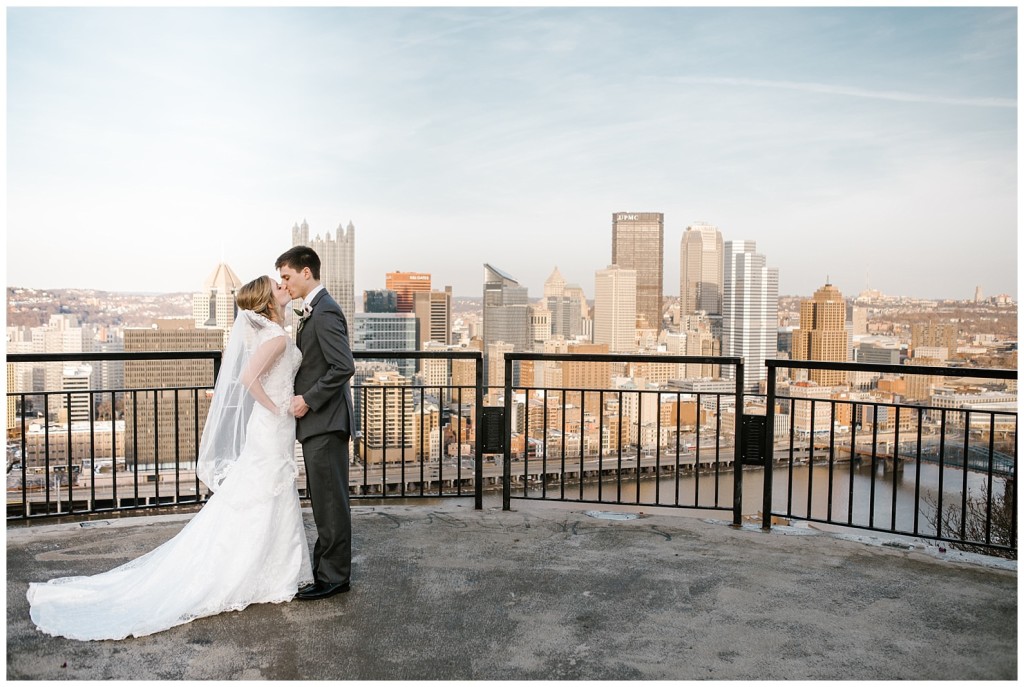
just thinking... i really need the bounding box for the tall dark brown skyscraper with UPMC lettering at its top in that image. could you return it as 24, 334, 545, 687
611, 212, 665, 332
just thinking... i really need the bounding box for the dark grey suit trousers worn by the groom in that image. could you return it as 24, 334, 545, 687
302, 432, 352, 585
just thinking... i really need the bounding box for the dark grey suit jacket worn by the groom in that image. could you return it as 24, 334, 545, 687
295, 290, 355, 441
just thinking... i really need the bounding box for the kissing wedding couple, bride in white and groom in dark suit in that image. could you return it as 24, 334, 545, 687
28, 246, 355, 640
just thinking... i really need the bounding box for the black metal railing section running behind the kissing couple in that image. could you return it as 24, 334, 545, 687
7, 351, 487, 520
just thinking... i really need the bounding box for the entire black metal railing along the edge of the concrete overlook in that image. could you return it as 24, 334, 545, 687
7, 351, 1017, 552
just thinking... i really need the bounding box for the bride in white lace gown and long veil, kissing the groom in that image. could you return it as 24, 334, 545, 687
28, 276, 313, 640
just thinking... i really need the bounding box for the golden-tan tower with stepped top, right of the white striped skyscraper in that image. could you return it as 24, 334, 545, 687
793, 284, 849, 386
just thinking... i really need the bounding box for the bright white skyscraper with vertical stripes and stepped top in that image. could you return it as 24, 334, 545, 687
722, 241, 778, 390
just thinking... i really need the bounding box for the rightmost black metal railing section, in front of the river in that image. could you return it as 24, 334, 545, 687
761, 360, 1017, 552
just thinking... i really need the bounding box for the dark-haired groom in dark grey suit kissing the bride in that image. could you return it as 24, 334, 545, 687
274, 246, 355, 600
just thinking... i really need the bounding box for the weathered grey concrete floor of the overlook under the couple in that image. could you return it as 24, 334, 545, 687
6, 498, 1017, 680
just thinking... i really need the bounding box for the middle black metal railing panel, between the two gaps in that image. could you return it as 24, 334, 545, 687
503, 353, 744, 525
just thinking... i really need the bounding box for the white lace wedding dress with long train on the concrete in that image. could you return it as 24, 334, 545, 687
28, 313, 313, 640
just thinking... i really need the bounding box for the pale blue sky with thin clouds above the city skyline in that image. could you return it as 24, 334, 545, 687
6, 6, 1018, 301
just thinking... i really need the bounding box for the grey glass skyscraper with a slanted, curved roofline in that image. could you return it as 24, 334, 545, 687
483, 264, 534, 384
